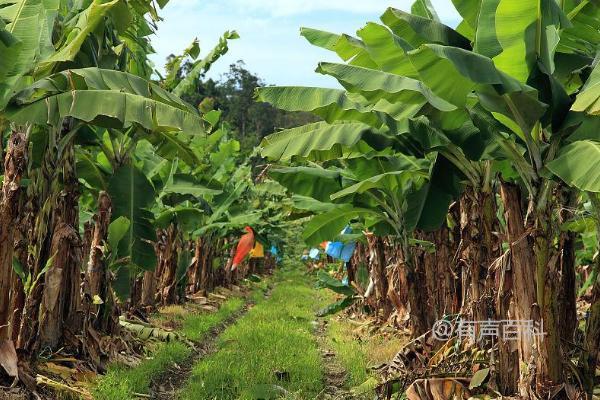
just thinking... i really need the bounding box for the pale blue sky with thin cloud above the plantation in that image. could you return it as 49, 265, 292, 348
151, 0, 459, 87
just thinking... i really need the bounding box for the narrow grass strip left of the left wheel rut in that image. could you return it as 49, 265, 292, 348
92, 280, 267, 400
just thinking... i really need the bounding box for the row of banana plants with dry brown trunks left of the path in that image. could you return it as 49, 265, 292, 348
0, 0, 283, 390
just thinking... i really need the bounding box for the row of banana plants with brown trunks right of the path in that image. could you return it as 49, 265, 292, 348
258, 0, 600, 398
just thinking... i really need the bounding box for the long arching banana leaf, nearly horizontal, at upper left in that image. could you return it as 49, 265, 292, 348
7, 68, 204, 134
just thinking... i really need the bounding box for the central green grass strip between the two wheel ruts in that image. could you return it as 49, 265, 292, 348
181, 270, 323, 400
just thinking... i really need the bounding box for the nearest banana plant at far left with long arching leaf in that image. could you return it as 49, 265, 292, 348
0, 0, 232, 347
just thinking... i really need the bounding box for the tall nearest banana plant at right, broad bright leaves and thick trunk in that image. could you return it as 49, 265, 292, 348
258, 0, 598, 395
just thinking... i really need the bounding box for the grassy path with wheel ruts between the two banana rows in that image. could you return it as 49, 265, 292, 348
94, 267, 402, 400
